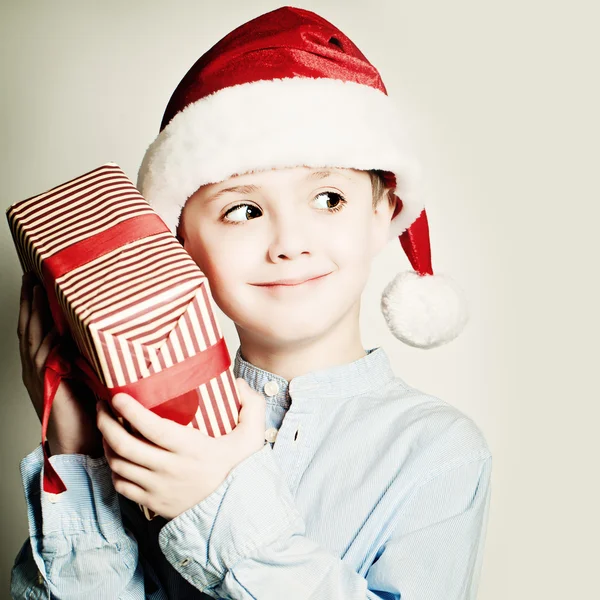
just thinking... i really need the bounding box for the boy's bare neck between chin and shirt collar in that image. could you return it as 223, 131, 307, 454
238, 310, 367, 382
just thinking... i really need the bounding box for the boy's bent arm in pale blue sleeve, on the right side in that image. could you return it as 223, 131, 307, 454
159, 444, 491, 600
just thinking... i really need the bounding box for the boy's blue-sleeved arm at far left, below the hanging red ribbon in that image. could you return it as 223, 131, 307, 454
11, 445, 150, 600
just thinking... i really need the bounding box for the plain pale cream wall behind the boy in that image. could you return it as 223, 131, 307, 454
0, 0, 600, 600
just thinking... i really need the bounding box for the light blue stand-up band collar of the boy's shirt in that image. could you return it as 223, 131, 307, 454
233, 347, 394, 408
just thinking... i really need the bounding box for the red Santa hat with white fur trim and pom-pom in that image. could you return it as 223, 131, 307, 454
138, 7, 467, 348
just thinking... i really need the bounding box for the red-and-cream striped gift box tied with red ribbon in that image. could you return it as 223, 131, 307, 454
7, 163, 240, 517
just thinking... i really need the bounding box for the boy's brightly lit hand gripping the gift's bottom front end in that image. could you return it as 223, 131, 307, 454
97, 378, 265, 519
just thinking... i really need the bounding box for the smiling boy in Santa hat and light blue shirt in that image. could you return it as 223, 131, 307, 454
12, 7, 491, 600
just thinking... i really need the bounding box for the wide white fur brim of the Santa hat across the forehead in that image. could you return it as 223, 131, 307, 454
138, 77, 424, 238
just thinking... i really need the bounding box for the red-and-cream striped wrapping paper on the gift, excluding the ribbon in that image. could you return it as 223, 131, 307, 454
7, 163, 240, 437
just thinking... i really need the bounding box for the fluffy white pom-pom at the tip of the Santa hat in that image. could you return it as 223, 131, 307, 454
381, 271, 468, 348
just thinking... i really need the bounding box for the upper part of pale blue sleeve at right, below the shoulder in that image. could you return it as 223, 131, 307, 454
367, 453, 492, 600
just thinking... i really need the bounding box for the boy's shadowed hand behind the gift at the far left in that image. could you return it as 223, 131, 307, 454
17, 273, 102, 457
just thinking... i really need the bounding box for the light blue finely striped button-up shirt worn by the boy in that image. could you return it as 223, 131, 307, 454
11, 348, 492, 600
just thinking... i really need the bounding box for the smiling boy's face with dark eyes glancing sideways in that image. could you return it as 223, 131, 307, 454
180, 167, 393, 348
